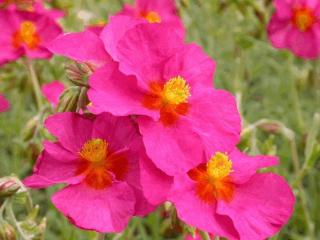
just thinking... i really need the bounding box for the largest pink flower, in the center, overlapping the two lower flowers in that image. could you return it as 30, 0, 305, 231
88, 24, 240, 176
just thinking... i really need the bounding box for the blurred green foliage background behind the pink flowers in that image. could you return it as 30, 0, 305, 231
0, 0, 320, 240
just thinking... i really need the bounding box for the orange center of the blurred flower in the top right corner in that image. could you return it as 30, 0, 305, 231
292, 7, 317, 32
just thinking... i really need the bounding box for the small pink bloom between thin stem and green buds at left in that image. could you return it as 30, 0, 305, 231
41, 81, 65, 107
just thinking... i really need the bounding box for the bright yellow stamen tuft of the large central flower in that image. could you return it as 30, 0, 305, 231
163, 76, 191, 105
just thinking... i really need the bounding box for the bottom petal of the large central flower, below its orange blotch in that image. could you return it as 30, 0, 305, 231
138, 117, 203, 176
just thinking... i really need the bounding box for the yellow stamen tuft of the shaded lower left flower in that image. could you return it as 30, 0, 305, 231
79, 138, 108, 163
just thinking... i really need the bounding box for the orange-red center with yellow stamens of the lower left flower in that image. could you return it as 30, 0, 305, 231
77, 138, 128, 190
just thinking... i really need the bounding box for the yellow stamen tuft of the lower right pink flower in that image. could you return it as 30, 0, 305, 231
207, 152, 232, 179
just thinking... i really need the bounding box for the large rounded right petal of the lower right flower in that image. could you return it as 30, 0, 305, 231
217, 173, 295, 240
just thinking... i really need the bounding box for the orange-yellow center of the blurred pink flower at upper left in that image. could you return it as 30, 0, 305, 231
12, 21, 41, 49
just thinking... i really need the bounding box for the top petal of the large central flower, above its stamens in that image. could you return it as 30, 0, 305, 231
118, 24, 184, 90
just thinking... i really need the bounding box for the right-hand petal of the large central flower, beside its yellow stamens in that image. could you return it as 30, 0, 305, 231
186, 87, 241, 154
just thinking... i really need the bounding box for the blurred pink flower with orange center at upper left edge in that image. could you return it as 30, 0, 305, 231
0, 9, 62, 64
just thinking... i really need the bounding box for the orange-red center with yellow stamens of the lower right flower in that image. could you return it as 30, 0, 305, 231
188, 152, 234, 203
